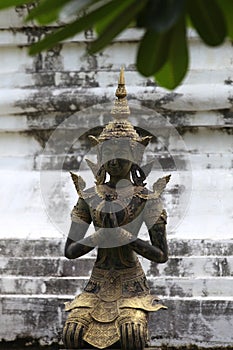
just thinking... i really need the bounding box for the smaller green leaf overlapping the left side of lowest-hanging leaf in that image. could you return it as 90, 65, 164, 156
137, 30, 170, 77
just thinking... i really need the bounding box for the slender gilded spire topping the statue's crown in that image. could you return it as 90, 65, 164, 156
111, 67, 130, 119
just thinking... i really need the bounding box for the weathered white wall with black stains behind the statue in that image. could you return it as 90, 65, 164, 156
0, 8, 233, 348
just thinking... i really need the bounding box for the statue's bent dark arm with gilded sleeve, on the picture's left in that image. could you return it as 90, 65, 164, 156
65, 198, 94, 259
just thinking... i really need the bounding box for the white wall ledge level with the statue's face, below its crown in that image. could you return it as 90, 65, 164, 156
0, 154, 233, 175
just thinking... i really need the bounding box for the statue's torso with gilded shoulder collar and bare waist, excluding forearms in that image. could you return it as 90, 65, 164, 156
72, 180, 165, 270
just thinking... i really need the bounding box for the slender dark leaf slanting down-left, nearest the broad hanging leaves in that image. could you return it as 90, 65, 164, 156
89, 0, 144, 53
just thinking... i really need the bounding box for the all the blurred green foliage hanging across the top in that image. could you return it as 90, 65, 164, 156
0, 0, 233, 89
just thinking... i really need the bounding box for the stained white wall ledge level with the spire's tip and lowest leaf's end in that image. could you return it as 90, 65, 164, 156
0, 68, 233, 89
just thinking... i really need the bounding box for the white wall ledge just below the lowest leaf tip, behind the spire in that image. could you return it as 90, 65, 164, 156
0, 84, 233, 115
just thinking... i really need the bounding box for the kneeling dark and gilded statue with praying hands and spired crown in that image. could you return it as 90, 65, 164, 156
63, 69, 170, 350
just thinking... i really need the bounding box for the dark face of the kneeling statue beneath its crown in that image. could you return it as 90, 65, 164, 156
101, 142, 132, 178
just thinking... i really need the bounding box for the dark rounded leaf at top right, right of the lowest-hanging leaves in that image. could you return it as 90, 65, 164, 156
187, 0, 227, 46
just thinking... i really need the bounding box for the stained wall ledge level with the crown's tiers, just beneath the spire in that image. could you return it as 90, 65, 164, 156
0, 111, 233, 134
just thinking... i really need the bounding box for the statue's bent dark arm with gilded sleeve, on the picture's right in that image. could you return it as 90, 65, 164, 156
130, 200, 168, 263
